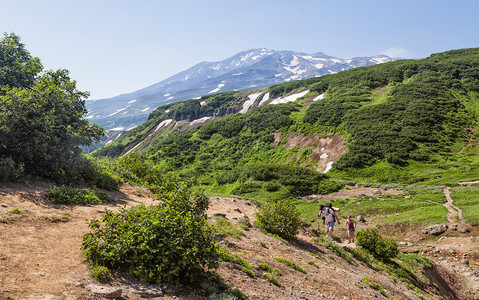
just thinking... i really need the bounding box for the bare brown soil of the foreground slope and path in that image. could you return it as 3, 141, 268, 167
0, 182, 479, 299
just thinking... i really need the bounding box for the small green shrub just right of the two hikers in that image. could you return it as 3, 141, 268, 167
356, 229, 399, 261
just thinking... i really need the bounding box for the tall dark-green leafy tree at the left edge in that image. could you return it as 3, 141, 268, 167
0, 34, 103, 182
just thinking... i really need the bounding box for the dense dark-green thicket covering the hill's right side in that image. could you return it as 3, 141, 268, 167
304, 49, 479, 169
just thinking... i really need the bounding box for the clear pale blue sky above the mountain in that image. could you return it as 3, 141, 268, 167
0, 0, 479, 99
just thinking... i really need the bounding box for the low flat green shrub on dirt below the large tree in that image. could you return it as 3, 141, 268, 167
46, 187, 112, 204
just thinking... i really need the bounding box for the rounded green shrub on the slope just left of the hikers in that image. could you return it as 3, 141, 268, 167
256, 200, 301, 241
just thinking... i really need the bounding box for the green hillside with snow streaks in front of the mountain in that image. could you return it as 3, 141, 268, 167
95, 48, 479, 190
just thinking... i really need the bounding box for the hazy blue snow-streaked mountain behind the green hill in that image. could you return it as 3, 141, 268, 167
86, 49, 393, 130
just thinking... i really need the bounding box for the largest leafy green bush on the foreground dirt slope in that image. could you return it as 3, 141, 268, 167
82, 181, 218, 282
